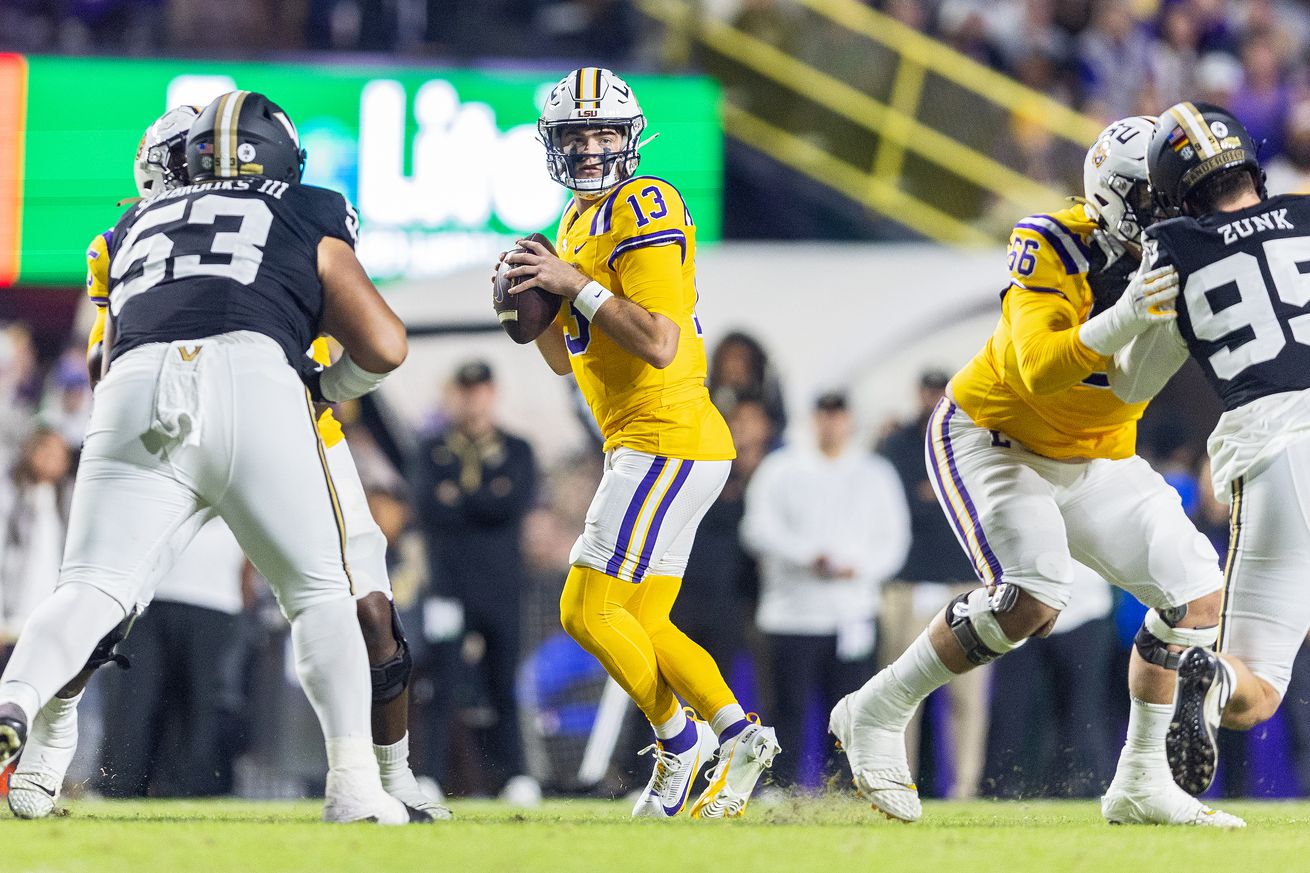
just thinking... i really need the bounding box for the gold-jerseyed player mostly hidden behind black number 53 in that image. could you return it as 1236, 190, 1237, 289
9, 106, 451, 821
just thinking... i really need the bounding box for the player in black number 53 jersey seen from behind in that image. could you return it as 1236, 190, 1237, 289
0, 92, 426, 823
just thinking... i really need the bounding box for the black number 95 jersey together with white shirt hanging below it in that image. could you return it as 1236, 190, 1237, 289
1142, 194, 1310, 495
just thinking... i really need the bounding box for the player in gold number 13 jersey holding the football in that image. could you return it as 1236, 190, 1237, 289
506, 67, 778, 818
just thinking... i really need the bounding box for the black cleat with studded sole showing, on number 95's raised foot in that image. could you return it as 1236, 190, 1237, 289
1165, 646, 1233, 796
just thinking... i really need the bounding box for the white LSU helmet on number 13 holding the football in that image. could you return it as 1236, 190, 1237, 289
537, 67, 654, 198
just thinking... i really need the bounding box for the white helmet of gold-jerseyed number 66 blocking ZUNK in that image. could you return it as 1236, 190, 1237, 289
1082, 115, 1155, 245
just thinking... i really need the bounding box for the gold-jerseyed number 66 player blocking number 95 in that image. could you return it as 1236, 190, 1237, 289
829, 117, 1243, 827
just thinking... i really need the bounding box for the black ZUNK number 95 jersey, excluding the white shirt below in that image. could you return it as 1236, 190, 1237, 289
1144, 194, 1310, 410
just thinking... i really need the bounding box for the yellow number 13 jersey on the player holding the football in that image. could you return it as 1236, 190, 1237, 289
555, 176, 736, 460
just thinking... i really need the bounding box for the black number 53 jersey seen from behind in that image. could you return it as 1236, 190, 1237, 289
109, 178, 359, 368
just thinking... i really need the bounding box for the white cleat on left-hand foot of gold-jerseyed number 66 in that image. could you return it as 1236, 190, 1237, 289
828, 695, 924, 822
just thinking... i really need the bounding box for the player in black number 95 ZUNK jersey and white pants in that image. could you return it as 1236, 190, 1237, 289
1116, 102, 1310, 793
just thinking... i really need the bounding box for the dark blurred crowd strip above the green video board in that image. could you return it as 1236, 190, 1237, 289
0, 0, 637, 63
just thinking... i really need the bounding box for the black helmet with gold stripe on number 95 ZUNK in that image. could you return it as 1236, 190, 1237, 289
1146, 102, 1265, 219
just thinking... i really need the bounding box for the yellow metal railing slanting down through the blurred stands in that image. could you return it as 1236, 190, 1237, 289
637, 0, 1100, 245
